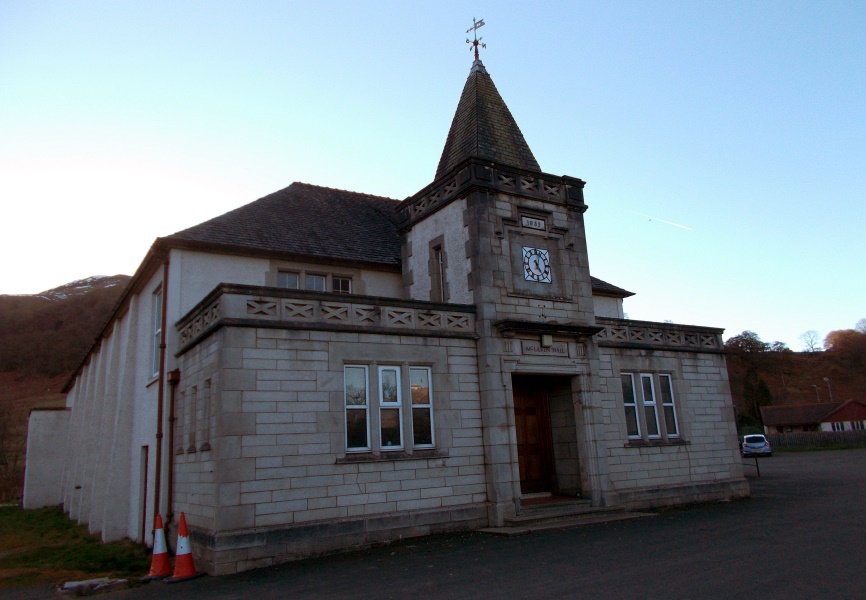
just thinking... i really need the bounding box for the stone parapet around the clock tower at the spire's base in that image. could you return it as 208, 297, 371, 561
397, 158, 586, 229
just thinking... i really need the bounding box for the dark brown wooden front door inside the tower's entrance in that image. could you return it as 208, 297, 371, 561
514, 377, 554, 494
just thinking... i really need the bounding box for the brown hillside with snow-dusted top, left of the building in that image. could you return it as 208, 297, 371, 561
0, 275, 129, 501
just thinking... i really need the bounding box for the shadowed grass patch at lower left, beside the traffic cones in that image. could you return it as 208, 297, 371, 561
0, 507, 150, 588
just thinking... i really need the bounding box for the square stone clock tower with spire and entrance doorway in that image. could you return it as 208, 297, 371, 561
398, 52, 606, 522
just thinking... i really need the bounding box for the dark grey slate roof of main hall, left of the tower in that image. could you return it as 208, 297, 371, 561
164, 182, 400, 266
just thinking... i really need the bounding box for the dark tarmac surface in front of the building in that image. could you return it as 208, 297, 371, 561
8, 449, 866, 600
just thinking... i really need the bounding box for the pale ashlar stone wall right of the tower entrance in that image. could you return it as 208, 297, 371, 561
599, 347, 748, 507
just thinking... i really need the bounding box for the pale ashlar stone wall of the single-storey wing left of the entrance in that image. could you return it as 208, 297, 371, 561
175, 326, 487, 573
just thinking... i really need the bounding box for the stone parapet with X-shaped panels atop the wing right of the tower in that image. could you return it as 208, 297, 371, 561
595, 317, 725, 354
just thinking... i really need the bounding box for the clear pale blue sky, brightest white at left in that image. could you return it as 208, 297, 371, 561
0, 0, 866, 350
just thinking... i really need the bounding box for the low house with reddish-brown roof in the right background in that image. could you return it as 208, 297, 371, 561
761, 400, 866, 434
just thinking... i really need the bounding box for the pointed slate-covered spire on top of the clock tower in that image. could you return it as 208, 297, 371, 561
436, 59, 541, 179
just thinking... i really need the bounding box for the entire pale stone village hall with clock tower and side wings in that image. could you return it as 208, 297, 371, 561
24, 50, 749, 574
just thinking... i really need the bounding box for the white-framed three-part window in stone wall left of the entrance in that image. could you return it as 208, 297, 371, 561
343, 365, 435, 453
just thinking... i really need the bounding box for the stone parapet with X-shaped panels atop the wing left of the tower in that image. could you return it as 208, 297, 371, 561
176, 284, 477, 353
